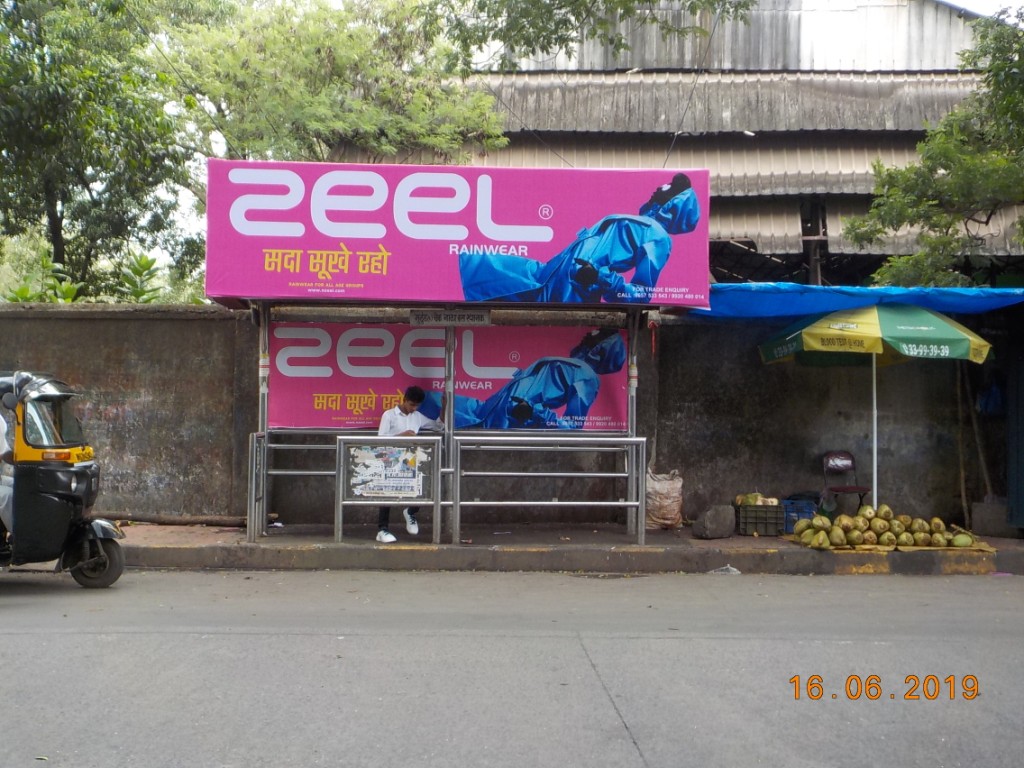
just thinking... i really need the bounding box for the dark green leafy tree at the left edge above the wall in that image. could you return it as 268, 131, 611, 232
0, 0, 185, 293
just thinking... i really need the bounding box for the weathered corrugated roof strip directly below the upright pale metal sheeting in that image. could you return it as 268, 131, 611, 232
475, 72, 978, 135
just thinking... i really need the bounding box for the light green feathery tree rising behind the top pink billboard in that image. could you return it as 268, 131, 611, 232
158, 0, 506, 165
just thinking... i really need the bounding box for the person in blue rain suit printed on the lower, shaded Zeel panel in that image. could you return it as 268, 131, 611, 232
420, 329, 626, 429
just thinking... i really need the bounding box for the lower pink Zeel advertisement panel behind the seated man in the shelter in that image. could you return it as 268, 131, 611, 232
267, 323, 628, 431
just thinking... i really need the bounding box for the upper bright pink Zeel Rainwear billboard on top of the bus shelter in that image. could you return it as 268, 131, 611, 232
206, 160, 709, 307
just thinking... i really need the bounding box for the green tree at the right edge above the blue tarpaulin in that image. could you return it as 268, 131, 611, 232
844, 9, 1024, 286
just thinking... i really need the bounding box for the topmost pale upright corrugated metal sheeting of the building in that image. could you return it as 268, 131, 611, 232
507, 0, 978, 72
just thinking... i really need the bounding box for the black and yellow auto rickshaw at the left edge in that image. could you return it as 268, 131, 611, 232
0, 371, 125, 588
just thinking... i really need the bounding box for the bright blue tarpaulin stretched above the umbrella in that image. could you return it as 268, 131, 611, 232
690, 283, 1024, 318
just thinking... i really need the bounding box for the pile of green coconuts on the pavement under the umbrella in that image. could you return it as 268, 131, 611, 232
793, 504, 977, 549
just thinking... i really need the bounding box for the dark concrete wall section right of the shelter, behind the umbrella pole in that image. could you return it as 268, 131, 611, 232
656, 313, 1006, 519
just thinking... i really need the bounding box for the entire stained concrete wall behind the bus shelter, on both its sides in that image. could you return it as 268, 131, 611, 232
0, 304, 1006, 523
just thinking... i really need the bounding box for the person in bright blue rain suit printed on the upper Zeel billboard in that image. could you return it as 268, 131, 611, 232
459, 173, 700, 304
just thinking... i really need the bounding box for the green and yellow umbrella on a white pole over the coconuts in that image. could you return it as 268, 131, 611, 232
758, 304, 991, 505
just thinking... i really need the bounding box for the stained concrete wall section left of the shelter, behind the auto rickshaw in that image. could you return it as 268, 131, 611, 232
0, 304, 259, 517
